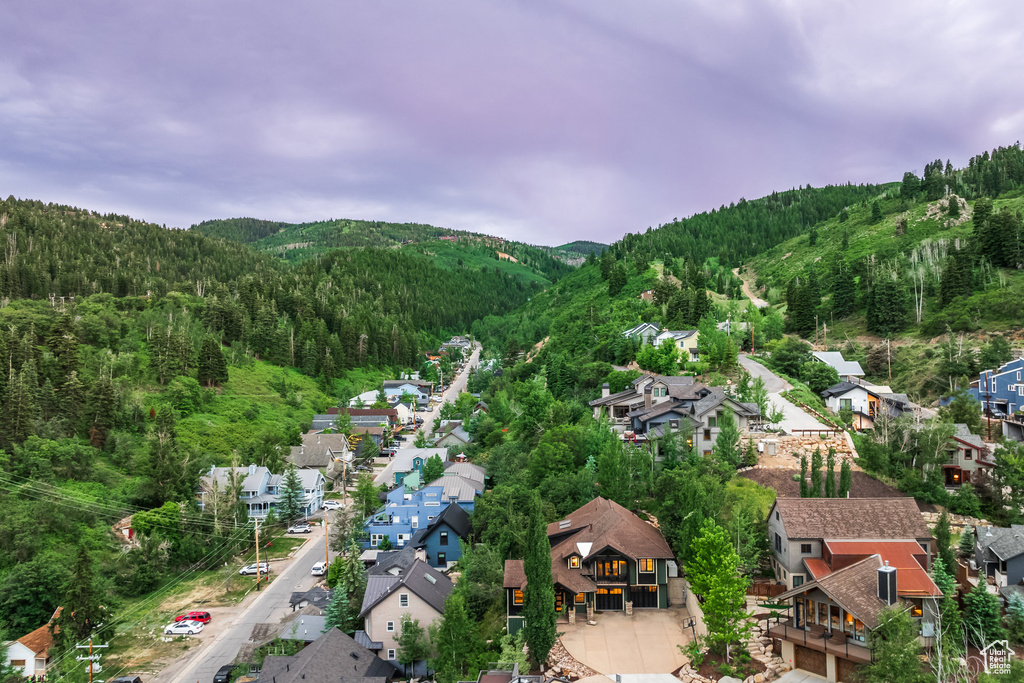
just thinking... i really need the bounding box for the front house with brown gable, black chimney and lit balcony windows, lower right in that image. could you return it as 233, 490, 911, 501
768, 557, 941, 681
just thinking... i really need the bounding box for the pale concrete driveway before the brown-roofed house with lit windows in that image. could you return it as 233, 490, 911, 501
558, 607, 692, 674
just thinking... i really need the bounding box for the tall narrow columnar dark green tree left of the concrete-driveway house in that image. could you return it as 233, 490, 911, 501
522, 493, 557, 664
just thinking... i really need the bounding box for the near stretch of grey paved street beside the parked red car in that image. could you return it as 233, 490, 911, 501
154, 528, 335, 683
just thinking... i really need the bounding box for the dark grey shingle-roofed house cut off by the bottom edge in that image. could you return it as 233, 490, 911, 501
256, 629, 398, 683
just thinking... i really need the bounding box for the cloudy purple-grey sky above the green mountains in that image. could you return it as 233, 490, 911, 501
0, 0, 1024, 245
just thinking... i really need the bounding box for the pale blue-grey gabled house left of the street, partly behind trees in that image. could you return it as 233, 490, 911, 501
197, 465, 325, 519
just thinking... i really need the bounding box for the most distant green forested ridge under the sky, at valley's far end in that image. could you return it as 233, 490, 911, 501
189, 218, 571, 285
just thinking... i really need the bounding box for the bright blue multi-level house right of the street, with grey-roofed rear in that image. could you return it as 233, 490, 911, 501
362, 463, 484, 552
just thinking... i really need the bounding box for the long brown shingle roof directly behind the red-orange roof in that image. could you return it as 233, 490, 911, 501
774, 498, 932, 539
